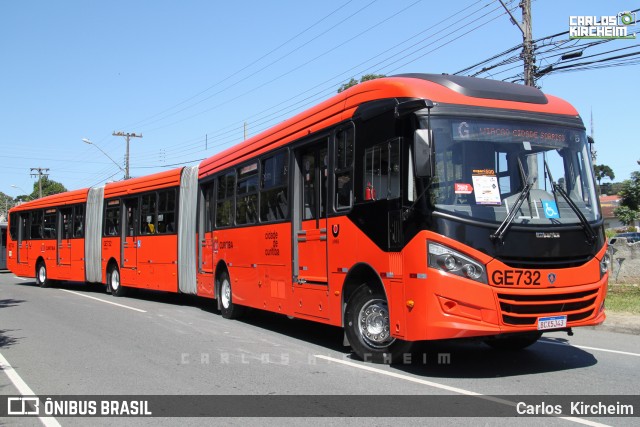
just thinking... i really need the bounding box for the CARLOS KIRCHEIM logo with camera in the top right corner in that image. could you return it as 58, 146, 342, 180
569, 12, 636, 39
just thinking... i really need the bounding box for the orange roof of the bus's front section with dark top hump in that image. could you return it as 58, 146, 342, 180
199, 74, 578, 178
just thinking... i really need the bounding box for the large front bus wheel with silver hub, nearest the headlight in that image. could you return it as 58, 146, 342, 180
345, 285, 411, 364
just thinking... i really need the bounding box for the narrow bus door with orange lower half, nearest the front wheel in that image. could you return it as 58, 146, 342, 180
292, 140, 328, 291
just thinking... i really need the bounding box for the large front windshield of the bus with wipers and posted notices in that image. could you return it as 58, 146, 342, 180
422, 117, 599, 225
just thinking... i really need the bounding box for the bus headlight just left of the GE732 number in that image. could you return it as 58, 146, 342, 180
427, 242, 487, 284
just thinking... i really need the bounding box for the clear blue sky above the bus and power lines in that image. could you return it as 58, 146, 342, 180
0, 0, 640, 197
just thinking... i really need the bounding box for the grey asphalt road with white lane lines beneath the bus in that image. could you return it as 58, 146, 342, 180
0, 273, 640, 426
